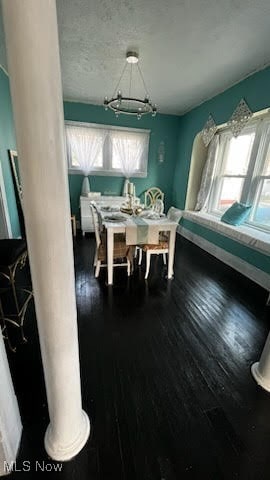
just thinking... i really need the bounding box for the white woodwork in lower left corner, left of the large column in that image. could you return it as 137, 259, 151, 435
0, 332, 22, 476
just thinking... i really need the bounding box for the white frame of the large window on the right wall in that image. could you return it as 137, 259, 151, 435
207, 115, 270, 232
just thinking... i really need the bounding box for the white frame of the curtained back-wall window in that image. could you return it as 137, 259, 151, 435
65, 121, 151, 178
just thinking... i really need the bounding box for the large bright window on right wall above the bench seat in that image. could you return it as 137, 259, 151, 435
208, 118, 270, 229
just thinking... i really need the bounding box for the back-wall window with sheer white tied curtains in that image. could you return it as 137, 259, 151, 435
66, 122, 150, 177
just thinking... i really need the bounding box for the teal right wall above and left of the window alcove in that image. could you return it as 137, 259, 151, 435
172, 67, 270, 208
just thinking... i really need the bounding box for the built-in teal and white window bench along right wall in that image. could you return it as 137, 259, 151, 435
178, 210, 270, 291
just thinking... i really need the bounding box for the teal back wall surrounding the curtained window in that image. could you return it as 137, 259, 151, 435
64, 102, 180, 215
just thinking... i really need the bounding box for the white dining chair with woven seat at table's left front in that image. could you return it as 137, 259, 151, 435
90, 203, 133, 278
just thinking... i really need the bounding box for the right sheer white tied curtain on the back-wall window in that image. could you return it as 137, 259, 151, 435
112, 131, 149, 195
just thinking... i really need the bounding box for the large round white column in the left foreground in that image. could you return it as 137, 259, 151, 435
2, 0, 90, 460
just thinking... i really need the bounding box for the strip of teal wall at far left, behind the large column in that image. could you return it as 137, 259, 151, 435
0, 68, 20, 238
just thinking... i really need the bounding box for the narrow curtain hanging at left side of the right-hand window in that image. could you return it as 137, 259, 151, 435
195, 135, 220, 211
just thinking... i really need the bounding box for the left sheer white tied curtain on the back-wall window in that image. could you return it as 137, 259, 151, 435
66, 125, 106, 194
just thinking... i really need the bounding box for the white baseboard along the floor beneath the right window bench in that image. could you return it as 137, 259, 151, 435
177, 225, 270, 291
